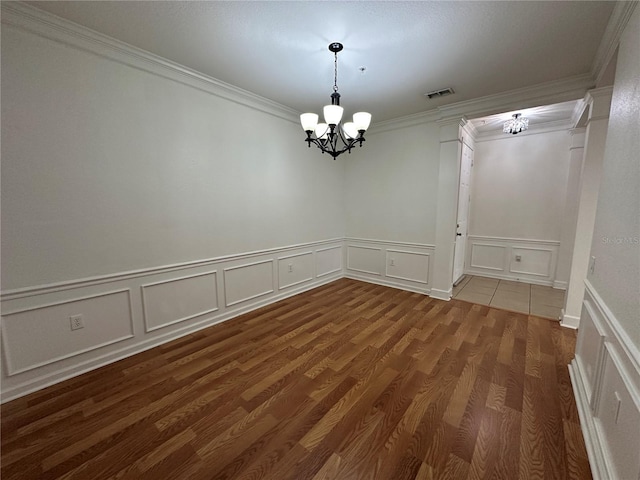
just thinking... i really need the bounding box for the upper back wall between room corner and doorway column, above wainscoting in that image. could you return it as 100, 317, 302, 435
345, 122, 440, 244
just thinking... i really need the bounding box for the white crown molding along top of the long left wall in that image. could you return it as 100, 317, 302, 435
1, 2, 299, 123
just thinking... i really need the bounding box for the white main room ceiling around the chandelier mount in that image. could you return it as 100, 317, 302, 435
28, 1, 615, 126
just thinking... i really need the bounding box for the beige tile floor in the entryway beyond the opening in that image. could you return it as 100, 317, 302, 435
453, 275, 565, 320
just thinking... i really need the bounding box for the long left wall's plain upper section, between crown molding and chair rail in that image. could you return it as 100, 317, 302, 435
2, 19, 344, 290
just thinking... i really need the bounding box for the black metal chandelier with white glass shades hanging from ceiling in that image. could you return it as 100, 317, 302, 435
300, 42, 371, 160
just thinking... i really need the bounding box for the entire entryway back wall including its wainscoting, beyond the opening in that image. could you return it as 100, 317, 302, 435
465, 127, 571, 285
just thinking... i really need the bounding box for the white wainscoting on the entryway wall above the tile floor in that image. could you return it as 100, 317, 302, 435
465, 235, 560, 286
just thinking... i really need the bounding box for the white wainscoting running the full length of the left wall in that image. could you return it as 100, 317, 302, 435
0, 238, 344, 402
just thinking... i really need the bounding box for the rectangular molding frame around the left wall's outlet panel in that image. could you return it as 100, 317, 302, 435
2, 288, 135, 377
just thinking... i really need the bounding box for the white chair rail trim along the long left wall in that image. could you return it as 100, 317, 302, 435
0, 238, 342, 302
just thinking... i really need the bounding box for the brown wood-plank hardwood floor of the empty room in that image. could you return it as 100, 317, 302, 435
1, 279, 591, 480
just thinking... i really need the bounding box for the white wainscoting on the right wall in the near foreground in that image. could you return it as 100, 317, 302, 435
569, 280, 640, 480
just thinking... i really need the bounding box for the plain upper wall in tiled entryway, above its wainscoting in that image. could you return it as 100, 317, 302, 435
469, 130, 571, 241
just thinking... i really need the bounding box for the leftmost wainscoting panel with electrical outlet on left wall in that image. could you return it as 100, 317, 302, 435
2, 289, 134, 376
